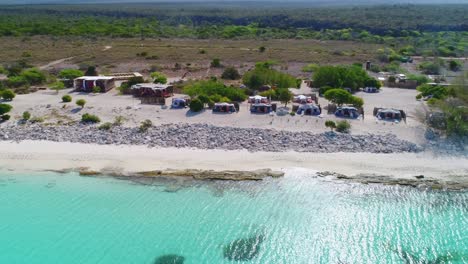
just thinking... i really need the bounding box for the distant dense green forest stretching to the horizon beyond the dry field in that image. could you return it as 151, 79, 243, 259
0, 2, 468, 56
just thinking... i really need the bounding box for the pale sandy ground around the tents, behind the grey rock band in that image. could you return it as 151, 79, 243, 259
3, 84, 424, 143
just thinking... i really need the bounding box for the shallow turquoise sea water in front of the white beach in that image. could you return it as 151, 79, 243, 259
0, 171, 468, 264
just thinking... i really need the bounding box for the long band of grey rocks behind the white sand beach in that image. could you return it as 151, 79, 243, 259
0, 124, 422, 153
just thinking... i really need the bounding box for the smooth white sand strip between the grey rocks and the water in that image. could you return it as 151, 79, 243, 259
0, 140, 468, 190
